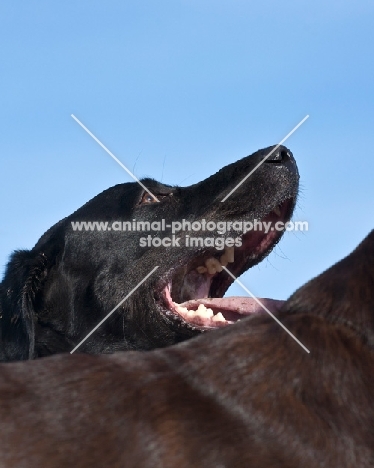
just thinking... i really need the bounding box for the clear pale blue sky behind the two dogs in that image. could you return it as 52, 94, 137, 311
0, 0, 374, 299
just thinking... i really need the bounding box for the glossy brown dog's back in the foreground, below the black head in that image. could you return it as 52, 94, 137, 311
0, 231, 374, 468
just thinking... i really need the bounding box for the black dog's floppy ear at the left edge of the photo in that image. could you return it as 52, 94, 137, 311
0, 250, 47, 361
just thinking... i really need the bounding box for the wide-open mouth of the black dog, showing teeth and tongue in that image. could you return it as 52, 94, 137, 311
158, 198, 295, 329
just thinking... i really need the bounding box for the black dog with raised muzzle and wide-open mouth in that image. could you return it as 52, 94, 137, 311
0, 146, 299, 361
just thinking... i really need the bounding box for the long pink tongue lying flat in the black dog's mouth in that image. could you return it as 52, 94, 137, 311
180, 297, 284, 316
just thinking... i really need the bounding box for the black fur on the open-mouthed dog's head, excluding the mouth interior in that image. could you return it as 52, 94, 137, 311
0, 147, 298, 361
